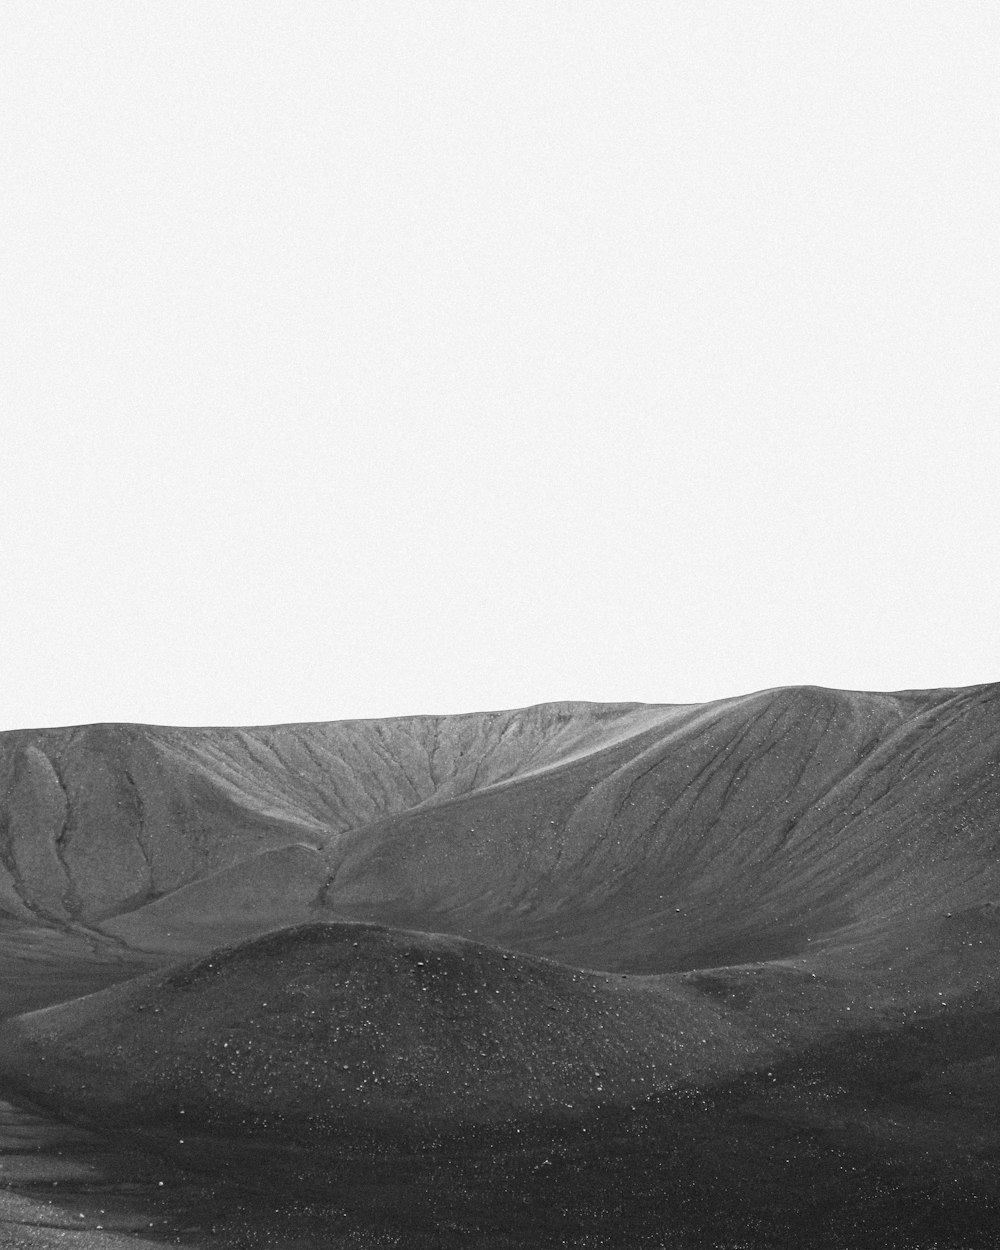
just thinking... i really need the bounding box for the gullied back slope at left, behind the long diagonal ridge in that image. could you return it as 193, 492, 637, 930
0, 704, 673, 921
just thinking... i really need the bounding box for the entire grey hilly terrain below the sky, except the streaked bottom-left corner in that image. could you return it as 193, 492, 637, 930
0, 685, 1000, 1250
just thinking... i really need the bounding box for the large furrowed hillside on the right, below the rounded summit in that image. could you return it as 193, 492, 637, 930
328, 686, 1000, 973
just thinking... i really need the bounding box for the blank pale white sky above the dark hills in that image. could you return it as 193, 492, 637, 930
0, 0, 1000, 729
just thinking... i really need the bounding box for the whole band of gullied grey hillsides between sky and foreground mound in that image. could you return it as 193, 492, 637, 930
0, 685, 1000, 974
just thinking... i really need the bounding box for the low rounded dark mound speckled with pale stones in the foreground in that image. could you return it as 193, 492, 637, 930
0, 924, 764, 1154
